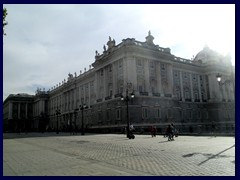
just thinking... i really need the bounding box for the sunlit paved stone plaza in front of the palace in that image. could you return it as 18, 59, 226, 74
3, 133, 235, 176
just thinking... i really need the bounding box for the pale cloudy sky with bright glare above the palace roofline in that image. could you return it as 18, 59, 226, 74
3, 4, 235, 100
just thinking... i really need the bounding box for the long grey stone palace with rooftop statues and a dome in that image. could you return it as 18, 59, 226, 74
4, 32, 235, 134
